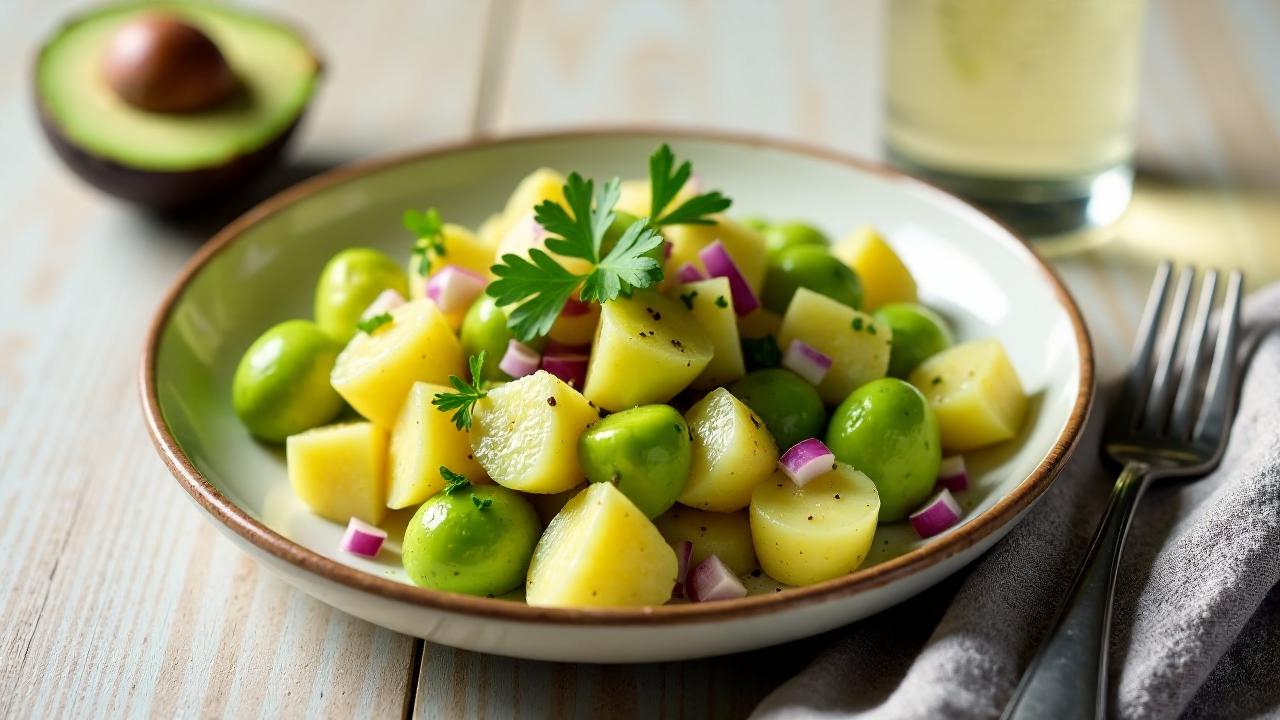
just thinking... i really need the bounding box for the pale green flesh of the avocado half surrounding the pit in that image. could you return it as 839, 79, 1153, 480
36, 3, 319, 172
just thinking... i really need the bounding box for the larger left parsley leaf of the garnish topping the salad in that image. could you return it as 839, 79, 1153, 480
486, 173, 662, 341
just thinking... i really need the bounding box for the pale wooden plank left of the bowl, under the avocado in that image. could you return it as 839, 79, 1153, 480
0, 3, 488, 717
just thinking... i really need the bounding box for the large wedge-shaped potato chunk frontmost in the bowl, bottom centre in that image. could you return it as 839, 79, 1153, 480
525, 483, 677, 607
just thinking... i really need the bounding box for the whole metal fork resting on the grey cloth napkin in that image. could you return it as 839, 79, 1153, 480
1004, 261, 1243, 720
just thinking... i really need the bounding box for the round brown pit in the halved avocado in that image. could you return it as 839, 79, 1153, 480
102, 13, 239, 113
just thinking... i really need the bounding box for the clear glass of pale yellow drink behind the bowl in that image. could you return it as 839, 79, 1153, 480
884, 0, 1144, 233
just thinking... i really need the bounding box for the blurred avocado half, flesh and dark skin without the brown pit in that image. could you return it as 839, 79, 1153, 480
35, 3, 320, 210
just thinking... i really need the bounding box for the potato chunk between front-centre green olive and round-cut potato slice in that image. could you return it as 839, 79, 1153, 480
678, 387, 778, 512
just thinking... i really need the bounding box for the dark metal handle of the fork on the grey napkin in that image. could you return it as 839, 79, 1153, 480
1004, 462, 1151, 720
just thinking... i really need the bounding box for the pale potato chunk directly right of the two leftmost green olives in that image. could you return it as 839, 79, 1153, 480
329, 300, 463, 428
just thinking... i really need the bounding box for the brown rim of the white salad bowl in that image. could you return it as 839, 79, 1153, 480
140, 126, 1094, 625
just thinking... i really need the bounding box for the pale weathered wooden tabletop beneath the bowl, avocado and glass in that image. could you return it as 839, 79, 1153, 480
0, 0, 1280, 717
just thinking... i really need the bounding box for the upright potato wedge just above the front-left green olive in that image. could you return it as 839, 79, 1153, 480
387, 383, 485, 510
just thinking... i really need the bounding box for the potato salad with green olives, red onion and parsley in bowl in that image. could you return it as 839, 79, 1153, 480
232, 145, 1027, 607
